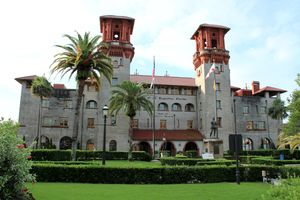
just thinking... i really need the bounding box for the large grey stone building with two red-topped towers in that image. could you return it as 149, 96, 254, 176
16, 15, 286, 155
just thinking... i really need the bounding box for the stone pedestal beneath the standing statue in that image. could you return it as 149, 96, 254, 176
203, 138, 224, 158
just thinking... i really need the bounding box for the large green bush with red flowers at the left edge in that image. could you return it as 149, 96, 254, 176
0, 119, 35, 200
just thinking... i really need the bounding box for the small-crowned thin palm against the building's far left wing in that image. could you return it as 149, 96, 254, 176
31, 76, 52, 148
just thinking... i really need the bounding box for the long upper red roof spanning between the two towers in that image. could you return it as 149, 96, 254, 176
130, 75, 197, 87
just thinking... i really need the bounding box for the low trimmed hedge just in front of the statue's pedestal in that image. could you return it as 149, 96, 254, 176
160, 157, 235, 166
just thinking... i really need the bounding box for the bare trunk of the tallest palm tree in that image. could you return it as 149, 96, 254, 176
71, 79, 85, 161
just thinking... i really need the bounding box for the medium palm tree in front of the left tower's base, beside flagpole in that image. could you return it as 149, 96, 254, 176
109, 81, 153, 160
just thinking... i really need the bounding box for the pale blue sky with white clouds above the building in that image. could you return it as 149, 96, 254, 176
0, 0, 300, 121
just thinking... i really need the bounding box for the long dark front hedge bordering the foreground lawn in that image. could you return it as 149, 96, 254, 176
32, 164, 300, 184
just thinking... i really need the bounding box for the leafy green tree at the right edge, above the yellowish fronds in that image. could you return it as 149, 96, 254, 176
283, 74, 300, 135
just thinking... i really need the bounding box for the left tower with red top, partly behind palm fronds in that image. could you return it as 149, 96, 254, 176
98, 15, 134, 151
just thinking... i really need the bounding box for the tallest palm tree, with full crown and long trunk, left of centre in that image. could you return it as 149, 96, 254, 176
51, 33, 113, 160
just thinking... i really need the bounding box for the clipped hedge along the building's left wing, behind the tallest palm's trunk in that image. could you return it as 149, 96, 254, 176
31, 149, 151, 161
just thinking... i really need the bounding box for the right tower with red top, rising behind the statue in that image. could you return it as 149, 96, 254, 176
191, 24, 233, 152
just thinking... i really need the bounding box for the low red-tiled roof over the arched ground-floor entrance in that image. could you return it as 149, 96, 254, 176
132, 129, 203, 141
